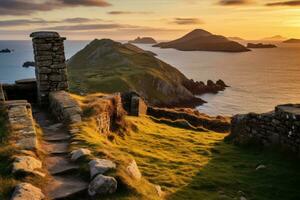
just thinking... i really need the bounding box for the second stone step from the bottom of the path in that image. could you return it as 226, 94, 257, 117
44, 156, 79, 175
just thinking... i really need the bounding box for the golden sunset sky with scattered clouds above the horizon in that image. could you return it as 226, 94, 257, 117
0, 0, 300, 40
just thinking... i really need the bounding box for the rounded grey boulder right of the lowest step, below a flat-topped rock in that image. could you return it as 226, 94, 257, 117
88, 174, 118, 196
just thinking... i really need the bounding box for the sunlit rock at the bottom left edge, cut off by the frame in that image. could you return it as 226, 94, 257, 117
11, 183, 45, 200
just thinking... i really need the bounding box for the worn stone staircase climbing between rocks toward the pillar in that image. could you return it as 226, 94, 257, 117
33, 109, 88, 199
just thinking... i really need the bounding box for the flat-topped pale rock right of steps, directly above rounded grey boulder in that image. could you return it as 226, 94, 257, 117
89, 159, 116, 178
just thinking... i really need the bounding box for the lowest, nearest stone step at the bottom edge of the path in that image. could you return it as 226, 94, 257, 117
45, 176, 88, 199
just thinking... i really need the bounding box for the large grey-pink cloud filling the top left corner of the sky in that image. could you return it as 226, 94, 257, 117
0, 0, 111, 15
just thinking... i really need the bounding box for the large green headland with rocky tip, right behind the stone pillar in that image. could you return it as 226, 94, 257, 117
67, 39, 227, 107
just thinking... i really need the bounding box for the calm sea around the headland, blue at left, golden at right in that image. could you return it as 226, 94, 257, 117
0, 41, 300, 115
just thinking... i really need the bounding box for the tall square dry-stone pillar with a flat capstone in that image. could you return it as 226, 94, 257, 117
30, 32, 68, 105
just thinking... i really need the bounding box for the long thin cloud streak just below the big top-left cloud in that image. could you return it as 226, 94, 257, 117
0, 17, 104, 27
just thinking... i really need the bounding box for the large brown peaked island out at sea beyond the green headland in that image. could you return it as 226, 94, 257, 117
154, 29, 250, 52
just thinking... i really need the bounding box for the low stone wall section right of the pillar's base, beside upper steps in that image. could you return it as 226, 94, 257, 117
49, 91, 82, 123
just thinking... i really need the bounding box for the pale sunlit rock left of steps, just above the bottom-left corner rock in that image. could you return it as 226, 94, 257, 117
12, 156, 45, 177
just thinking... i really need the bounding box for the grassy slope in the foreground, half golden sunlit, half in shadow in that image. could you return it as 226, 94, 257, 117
69, 94, 300, 200
